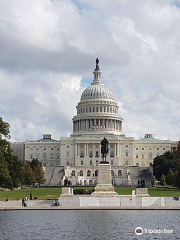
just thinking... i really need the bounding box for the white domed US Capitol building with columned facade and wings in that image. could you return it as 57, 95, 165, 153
12, 59, 177, 185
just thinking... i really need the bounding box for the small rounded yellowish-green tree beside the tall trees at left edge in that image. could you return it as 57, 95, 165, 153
22, 163, 35, 185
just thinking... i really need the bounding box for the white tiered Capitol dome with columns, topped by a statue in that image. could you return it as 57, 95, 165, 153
72, 58, 123, 136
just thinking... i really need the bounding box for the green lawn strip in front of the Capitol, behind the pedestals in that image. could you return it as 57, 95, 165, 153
0, 187, 180, 201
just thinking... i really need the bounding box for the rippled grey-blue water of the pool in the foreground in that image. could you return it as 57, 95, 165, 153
0, 210, 180, 240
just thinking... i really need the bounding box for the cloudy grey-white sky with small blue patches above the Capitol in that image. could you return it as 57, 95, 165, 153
0, 0, 180, 141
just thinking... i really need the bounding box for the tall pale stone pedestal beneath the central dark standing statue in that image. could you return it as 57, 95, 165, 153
92, 163, 117, 196
